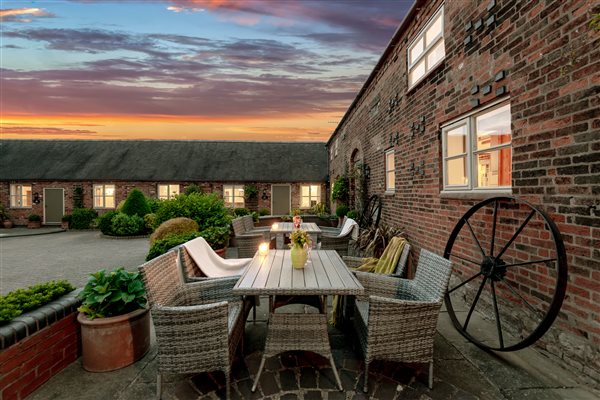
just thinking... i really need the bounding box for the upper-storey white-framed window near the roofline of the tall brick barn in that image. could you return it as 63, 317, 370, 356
408, 6, 446, 89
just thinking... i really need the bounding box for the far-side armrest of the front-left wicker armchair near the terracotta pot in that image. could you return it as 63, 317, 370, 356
183, 275, 241, 305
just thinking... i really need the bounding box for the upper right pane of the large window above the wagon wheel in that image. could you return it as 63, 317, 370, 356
475, 104, 511, 150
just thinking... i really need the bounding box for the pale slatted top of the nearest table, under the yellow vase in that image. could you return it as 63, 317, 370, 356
233, 250, 364, 295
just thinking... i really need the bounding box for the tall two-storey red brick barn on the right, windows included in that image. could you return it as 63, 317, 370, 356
328, 0, 600, 382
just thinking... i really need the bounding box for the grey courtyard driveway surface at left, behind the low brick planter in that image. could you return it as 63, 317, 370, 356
0, 231, 149, 295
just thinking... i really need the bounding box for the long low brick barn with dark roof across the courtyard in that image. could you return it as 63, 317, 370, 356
0, 140, 327, 225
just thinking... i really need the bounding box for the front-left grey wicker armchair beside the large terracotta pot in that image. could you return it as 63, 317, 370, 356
139, 251, 247, 399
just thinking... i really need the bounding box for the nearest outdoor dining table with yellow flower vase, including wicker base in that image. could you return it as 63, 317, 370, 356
233, 250, 364, 391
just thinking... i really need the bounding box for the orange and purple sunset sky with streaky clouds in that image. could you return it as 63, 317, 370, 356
0, 0, 412, 141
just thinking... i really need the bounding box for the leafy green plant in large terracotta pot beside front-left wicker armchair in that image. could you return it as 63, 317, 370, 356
77, 267, 150, 372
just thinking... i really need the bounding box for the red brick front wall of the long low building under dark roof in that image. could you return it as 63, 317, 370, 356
0, 181, 327, 225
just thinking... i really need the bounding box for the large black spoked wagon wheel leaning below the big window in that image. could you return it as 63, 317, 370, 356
444, 197, 567, 351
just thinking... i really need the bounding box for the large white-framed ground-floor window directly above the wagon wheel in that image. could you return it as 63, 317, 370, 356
442, 102, 512, 192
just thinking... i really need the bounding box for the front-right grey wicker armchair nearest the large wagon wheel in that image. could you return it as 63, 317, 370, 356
354, 250, 452, 392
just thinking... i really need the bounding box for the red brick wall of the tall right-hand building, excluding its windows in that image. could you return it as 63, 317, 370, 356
329, 0, 600, 380
